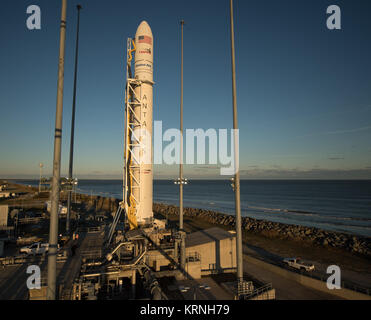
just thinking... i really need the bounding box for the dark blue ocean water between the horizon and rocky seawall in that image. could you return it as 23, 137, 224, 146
11, 180, 371, 237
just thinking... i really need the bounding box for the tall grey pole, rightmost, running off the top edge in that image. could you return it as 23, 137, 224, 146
230, 0, 243, 287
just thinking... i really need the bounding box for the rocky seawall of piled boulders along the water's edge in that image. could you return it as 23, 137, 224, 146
0, 180, 371, 258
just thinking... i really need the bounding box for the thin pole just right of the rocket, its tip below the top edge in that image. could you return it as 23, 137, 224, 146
179, 20, 186, 276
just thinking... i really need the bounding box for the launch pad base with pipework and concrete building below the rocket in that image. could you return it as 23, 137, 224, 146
61, 219, 274, 300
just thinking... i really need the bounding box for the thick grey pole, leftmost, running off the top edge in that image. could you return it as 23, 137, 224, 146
46, 0, 67, 300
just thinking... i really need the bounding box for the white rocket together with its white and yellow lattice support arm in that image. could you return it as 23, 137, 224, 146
124, 21, 154, 229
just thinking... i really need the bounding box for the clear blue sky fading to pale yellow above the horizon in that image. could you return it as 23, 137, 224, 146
0, 0, 371, 179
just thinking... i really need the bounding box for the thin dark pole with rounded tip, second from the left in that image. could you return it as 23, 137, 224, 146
66, 4, 82, 234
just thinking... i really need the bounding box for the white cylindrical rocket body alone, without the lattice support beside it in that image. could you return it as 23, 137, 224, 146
132, 21, 153, 225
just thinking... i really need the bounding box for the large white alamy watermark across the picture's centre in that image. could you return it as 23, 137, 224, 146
130, 121, 239, 175
